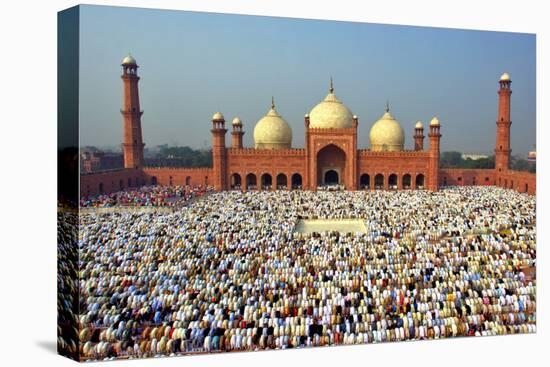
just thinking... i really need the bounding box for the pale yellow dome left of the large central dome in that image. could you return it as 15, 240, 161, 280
254, 103, 292, 149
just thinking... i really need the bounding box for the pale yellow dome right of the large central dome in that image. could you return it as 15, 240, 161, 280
369, 109, 405, 151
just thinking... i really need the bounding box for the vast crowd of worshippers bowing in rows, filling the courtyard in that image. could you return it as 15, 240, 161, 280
78, 186, 536, 360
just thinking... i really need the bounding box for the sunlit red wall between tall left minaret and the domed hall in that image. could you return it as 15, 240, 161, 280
143, 167, 214, 186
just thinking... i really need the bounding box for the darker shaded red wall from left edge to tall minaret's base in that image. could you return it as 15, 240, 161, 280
80, 168, 148, 196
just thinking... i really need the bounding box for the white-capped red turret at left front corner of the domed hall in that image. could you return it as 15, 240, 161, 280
210, 112, 227, 191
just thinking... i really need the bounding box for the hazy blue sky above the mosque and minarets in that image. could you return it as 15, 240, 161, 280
80, 5, 536, 155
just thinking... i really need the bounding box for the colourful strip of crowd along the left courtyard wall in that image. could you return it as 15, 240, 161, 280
80, 185, 212, 208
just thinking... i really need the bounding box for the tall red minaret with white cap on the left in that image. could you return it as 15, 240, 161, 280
120, 55, 145, 168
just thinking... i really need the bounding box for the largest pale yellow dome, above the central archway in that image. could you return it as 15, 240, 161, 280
309, 79, 353, 129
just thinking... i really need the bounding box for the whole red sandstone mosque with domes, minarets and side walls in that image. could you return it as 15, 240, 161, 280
80, 55, 536, 194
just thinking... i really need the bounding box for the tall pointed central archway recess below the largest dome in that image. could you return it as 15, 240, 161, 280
317, 144, 346, 186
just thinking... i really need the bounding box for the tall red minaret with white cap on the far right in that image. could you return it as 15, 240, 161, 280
495, 73, 512, 174
